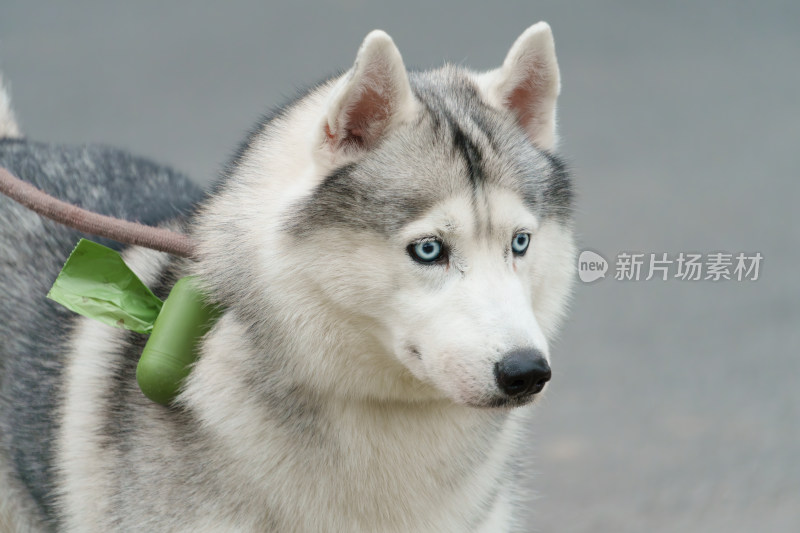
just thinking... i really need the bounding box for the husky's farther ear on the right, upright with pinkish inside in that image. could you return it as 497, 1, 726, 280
479, 22, 561, 150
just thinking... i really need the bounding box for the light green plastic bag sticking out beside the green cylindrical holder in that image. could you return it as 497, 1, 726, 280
47, 239, 163, 334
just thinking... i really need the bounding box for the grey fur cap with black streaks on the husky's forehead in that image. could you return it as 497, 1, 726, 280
290, 66, 572, 237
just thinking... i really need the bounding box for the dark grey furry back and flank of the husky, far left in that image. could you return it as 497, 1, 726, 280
0, 80, 201, 531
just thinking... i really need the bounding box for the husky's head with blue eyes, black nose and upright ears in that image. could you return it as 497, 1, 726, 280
198, 23, 574, 407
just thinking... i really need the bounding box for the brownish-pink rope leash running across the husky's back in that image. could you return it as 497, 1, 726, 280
0, 167, 196, 259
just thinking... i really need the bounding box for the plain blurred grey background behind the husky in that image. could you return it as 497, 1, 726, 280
0, 0, 800, 533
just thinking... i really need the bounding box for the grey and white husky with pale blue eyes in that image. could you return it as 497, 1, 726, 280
0, 23, 574, 533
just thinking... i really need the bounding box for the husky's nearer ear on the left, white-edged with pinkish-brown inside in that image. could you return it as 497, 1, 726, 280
322, 30, 416, 156
